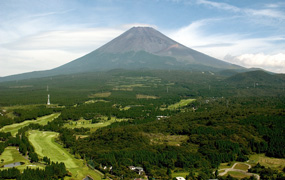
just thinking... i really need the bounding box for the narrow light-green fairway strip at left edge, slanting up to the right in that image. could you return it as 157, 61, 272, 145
0, 113, 60, 136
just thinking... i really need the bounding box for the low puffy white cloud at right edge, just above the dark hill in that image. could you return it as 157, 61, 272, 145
225, 53, 285, 73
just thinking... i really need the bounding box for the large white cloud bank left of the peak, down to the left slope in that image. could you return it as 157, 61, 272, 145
0, 28, 125, 76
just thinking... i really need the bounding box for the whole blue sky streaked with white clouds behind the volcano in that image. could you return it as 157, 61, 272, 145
0, 0, 285, 76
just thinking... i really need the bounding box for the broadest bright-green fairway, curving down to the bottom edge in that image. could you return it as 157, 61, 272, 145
29, 130, 101, 179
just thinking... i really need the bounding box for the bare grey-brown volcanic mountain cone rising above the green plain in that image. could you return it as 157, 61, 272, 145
0, 27, 243, 81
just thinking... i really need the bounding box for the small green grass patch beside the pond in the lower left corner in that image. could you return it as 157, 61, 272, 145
0, 146, 44, 170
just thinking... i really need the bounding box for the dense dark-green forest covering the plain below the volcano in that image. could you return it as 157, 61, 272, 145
0, 70, 285, 179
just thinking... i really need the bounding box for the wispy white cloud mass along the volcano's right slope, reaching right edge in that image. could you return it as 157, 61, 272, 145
168, 19, 285, 73
